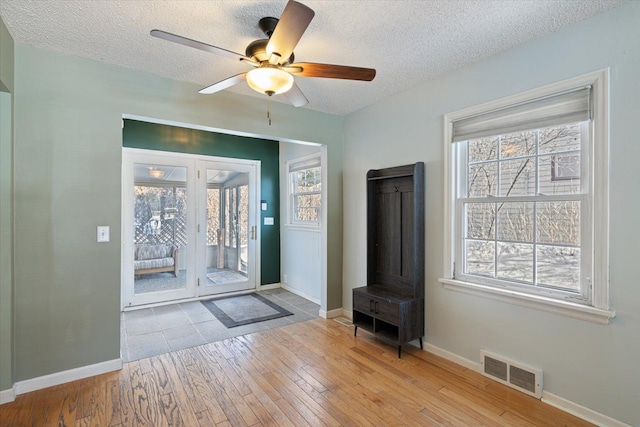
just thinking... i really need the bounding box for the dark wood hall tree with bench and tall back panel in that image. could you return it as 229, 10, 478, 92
353, 162, 424, 357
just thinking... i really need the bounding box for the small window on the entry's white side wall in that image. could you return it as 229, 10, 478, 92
288, 155, 322, 225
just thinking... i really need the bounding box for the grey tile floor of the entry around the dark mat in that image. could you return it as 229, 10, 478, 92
120, 289, 320, 362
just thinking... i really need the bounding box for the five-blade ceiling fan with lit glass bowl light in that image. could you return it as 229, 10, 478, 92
151, 0, 376, 107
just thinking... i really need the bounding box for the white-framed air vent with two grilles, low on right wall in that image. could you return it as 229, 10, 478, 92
480, 350, 542, 399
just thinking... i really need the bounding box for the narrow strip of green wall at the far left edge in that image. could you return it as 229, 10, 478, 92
0, 15, 13, 391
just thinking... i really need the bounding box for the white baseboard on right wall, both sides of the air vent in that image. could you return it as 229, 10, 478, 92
424, 342, 631, 427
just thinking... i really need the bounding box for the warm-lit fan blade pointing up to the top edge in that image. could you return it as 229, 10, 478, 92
267, 0, 315, 64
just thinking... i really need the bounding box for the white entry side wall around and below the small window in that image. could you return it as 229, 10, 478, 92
280, 142, 322, 303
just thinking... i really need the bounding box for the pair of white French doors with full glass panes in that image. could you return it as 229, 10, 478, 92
122, 148, 260, 308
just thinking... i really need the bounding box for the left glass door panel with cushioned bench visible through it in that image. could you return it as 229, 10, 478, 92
125, 157, 195, 306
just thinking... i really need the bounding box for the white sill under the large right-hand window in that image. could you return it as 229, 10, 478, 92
439, 279, 616, 325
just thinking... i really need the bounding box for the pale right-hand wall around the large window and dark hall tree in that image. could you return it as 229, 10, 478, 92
343, 2, 640, 425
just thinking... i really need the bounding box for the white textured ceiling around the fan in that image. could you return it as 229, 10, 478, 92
0, 0, 622, 115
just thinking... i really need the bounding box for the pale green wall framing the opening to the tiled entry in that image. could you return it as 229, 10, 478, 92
14, 43, 342, 381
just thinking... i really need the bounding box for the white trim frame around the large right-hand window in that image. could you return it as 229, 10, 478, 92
440, 69, 615, 325
